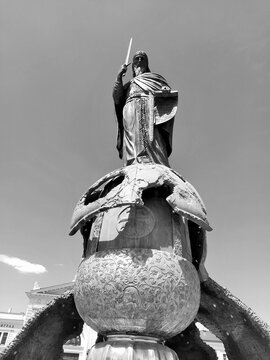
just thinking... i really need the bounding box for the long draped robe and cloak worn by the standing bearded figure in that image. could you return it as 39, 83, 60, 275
113, 72, 174, 166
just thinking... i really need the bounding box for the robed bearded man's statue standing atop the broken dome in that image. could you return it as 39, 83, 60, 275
113, 51, 178, 166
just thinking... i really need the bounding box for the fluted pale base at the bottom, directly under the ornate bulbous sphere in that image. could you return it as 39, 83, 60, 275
87, 335, 178, 360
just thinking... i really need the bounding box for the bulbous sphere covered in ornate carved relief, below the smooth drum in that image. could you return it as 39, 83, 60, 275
74, 249, 200, 339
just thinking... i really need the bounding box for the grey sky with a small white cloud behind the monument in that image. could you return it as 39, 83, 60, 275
0, 0, 270, 323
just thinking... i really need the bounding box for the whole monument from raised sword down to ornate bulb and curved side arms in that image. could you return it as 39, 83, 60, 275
2, 42, 270, 360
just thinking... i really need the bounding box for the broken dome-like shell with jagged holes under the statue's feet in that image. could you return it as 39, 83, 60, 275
70, 164, 212, 235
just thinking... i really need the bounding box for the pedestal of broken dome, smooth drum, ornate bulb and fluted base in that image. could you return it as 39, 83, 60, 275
71, 164, 209, 360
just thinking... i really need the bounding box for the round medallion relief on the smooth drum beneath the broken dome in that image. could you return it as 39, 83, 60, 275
117, 206, 155, 238
